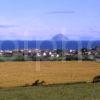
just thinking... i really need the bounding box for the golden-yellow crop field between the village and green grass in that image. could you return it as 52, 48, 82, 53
0, 61, 100, 88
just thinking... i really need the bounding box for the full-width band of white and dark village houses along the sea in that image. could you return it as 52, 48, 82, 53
0, 47, 100, 57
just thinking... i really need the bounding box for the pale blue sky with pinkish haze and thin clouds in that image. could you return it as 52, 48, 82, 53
0, 0, 100, 40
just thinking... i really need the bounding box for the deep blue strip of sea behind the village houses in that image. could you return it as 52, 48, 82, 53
0, 40, 100, 50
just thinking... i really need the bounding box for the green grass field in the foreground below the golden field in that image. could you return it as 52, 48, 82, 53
0, 83, 100, 100
